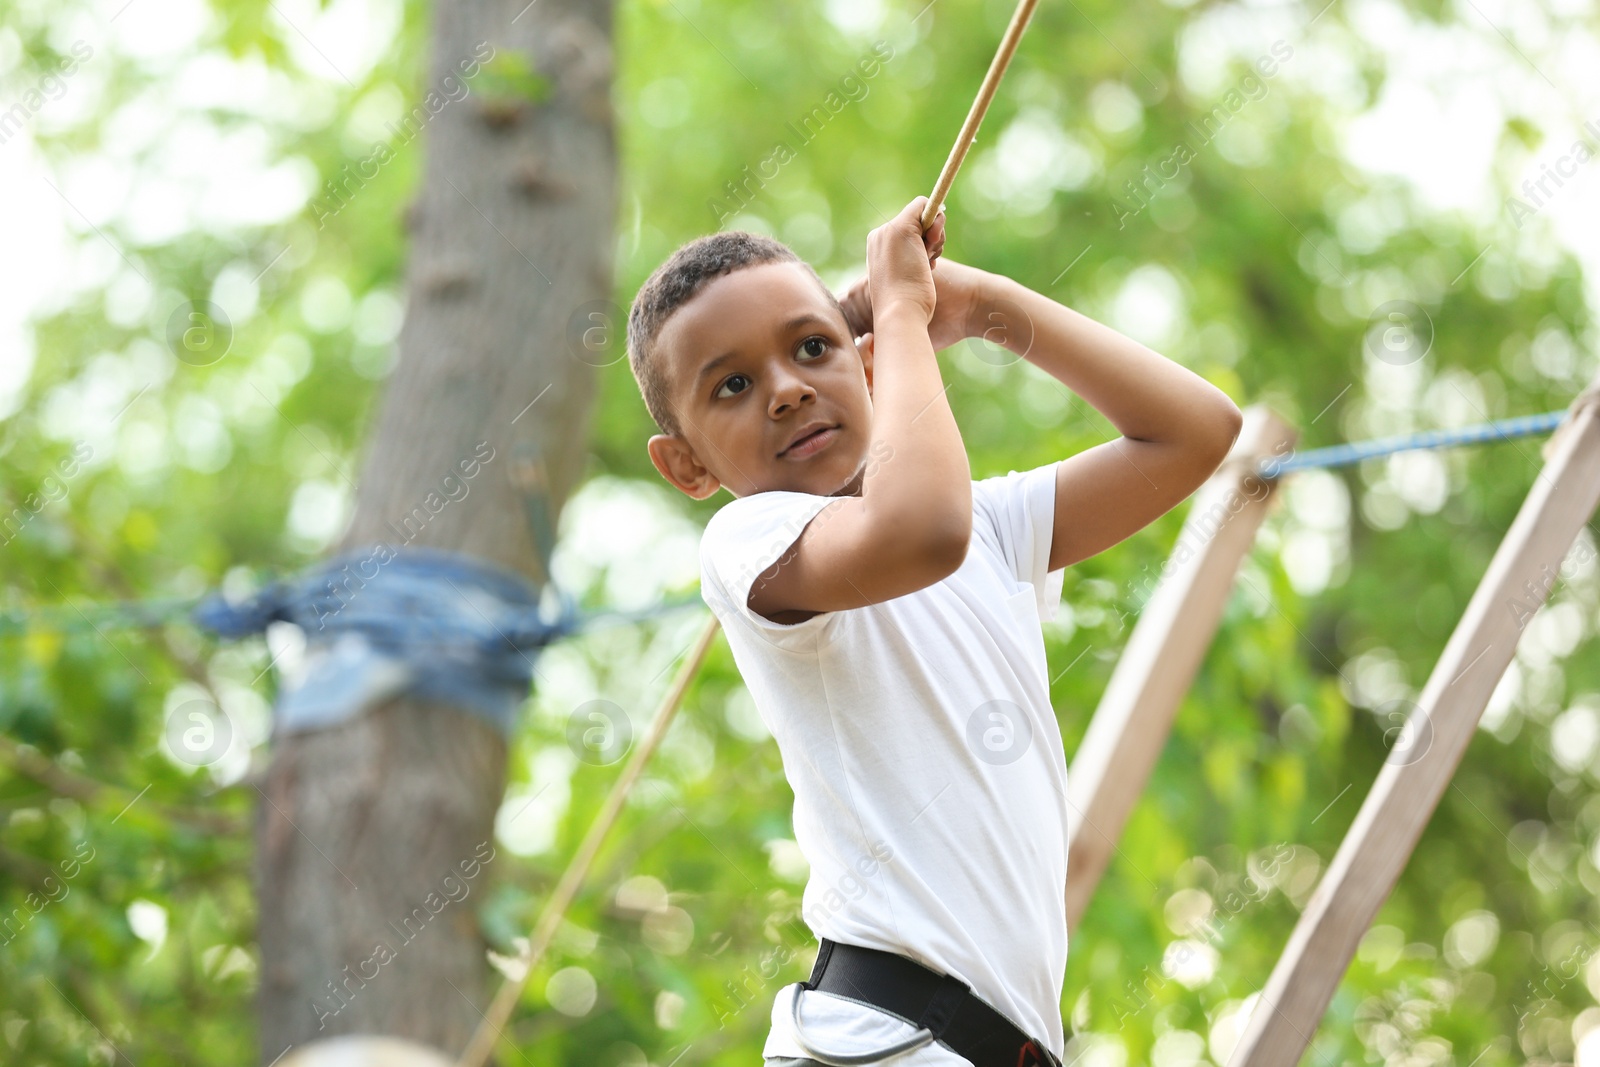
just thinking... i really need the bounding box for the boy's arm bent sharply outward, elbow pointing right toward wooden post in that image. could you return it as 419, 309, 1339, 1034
976, 274, 1242, 569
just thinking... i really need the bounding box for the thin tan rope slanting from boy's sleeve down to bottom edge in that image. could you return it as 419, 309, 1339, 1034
456, 616, 717, 1067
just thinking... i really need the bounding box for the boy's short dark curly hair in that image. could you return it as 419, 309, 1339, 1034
627, 230, 845, 434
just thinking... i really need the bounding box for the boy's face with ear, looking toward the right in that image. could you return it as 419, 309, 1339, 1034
650, 262, 872, 499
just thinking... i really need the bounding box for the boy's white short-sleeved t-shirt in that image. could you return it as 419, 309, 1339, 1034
701, 464, 1067, 1067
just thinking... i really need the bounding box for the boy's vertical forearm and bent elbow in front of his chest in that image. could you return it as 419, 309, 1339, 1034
749, 197, 973, 622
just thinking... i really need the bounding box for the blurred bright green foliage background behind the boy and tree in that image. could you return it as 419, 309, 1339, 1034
0, 0, 1600, 1067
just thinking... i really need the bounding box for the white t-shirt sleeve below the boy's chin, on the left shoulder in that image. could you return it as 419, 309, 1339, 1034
701, 490, 838, 637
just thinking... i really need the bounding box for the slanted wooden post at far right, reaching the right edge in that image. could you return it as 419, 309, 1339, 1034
1229, 378, 1600, 1067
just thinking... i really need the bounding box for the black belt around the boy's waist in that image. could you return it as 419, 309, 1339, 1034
795, 937, 1061, 1067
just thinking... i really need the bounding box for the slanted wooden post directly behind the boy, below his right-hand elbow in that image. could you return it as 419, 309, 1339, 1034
1066, 406, 1296, 929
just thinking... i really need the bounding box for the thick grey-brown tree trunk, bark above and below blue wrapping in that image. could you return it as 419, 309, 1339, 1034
256, 0, 621, 1064
